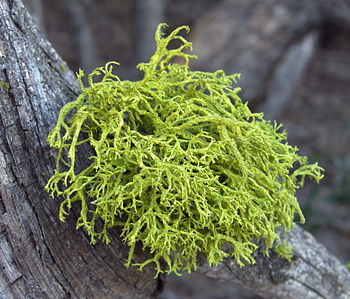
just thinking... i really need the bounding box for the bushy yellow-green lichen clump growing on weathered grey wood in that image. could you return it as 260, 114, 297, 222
46, 25, 322, 273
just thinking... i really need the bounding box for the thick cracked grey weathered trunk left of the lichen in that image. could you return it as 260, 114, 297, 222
0, 0, 158, 298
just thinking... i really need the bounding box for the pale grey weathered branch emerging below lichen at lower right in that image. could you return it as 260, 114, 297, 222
199, 226, 350, 299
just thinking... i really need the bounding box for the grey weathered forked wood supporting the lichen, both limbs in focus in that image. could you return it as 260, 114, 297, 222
0, 0, 350, 298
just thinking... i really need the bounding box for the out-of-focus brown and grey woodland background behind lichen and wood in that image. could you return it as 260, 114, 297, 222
23, 0, 350, 299
